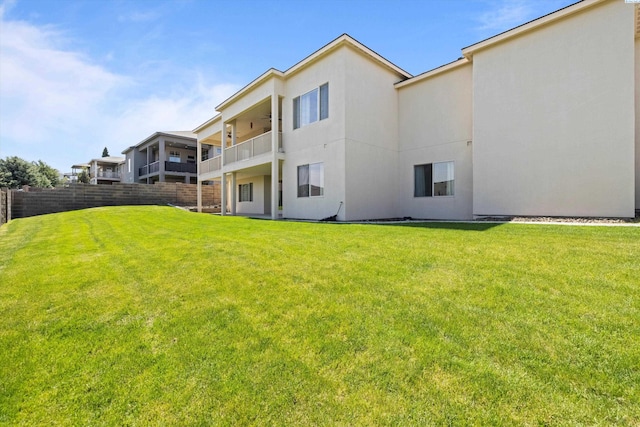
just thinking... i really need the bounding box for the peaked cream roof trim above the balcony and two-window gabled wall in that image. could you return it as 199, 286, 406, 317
210, 33, 413, 114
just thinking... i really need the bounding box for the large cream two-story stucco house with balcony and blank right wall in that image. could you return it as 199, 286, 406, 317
194, 0, 640, 220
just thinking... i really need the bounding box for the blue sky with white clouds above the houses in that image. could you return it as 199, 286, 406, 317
0, 0, 575, 172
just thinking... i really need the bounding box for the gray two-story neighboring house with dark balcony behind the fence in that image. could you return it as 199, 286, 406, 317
122, 131, 197, 184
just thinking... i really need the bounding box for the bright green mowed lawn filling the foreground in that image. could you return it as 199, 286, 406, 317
0, 207, 640, 425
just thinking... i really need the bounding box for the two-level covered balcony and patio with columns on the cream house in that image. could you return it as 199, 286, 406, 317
194, 88, 285, 219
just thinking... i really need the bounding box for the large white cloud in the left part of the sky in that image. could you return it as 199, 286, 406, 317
0, 8, 238, 171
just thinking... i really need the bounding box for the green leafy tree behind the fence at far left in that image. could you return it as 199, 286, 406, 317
0, 156, 60, 188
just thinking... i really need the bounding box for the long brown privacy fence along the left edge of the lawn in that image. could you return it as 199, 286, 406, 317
2, 182, 220, 223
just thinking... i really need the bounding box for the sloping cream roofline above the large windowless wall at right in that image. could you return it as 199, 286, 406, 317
462, 0, 609, 60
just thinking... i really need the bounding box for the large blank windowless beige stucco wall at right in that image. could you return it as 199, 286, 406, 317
473, 2, 636, 217
